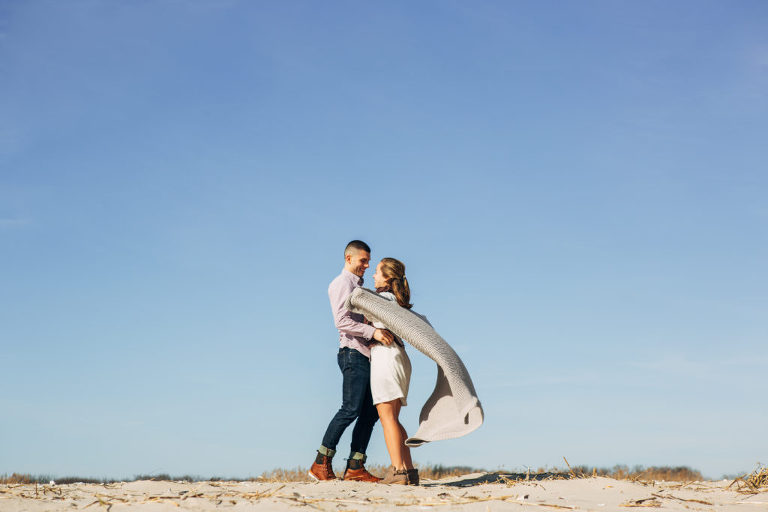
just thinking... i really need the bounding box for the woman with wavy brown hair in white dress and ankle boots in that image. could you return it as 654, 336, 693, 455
371, 258, 419, 485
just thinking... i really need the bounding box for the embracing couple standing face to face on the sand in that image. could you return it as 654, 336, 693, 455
309, 240, 419, 485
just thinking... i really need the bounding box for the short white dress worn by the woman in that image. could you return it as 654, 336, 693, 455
371, 292, 411, 406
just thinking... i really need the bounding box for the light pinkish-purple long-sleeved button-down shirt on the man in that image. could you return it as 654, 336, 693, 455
328, 269, 376, 358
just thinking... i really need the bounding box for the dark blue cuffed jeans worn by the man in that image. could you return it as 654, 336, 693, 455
323, 347, 379, 453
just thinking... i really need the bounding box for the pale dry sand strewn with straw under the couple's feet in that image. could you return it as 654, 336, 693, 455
0, 473, 768, 512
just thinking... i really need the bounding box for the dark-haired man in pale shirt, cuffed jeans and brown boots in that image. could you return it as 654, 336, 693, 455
309, 240, 394, 482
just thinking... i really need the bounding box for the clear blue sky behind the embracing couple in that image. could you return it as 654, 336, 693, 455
0, 0, 768, 478
